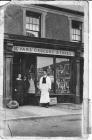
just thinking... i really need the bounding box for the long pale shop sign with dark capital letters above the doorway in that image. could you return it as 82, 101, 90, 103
12, 46, 75, 56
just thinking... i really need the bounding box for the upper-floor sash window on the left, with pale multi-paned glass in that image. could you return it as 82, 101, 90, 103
26, 11, 41, 37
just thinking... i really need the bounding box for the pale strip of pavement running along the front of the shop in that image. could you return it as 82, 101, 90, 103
0, 103, 82, 120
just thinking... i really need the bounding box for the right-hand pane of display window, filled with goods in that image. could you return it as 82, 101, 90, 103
56, 58, 71, 94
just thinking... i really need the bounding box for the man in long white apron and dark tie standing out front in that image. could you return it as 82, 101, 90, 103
39, 70, 51, 107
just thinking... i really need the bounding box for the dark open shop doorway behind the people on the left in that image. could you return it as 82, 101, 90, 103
13, 53, 36, 105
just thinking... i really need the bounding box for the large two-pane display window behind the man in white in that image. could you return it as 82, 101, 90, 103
37, 56, 71, 94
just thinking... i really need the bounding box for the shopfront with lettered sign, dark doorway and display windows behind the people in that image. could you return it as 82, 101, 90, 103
12, 46, 75, 104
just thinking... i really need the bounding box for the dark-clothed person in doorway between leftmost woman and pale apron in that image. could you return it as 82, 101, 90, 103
23, 76, 30, 104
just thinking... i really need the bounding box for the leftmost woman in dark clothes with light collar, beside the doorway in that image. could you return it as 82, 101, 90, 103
15, 74, 24, 106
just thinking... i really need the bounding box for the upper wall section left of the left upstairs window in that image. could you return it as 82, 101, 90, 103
4, 5, 23, 35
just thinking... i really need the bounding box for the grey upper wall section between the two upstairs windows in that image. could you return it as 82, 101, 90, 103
46, 13, 69, 41
